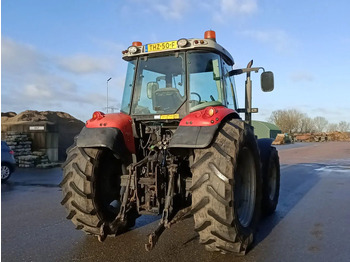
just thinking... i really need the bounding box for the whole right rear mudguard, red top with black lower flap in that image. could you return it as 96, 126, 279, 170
169, 106, 239, 149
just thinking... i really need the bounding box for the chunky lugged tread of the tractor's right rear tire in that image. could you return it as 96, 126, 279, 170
191, 119, 260, 255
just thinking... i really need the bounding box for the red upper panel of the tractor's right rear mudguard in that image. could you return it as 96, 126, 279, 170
180, 106, 237, 126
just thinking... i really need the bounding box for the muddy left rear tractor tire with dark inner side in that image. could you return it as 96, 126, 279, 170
60, 146, 136, 235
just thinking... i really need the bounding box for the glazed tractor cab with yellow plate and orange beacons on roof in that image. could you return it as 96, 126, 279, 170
121, 31, 237, 119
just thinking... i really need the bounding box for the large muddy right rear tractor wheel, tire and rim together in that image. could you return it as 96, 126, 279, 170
191, 119, 262, 255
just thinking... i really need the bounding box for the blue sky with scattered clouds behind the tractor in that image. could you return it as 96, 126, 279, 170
1, 0, 350, 123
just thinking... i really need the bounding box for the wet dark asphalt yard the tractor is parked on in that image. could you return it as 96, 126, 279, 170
1, 142, 350, 262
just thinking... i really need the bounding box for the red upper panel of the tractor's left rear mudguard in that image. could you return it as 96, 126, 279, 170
86, 111, 136, 154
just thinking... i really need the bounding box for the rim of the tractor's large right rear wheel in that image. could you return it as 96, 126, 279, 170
235, 148, 256, 227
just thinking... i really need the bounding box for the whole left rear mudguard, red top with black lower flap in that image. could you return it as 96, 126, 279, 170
77, 112, 135, 157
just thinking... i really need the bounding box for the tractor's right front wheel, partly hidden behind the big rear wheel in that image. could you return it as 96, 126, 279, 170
262, 147, 281, 216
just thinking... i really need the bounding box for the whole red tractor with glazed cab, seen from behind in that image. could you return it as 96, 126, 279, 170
60, 31, 280, 255
